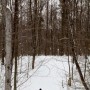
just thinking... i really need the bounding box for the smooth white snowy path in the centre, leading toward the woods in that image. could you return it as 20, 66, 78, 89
18, 56, 70, 90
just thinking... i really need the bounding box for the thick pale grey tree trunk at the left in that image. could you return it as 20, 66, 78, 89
5, 1, 12, 90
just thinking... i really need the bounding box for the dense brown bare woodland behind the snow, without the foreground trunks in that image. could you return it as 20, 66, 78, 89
0, 0, 90, 56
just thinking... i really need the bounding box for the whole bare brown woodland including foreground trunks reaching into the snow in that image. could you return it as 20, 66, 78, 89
0, 0, 90, 90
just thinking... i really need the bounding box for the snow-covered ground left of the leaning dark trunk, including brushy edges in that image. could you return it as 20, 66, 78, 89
0, 56, 90, 90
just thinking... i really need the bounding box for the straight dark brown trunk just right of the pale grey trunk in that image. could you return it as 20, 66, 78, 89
14, 0, 19, 90
